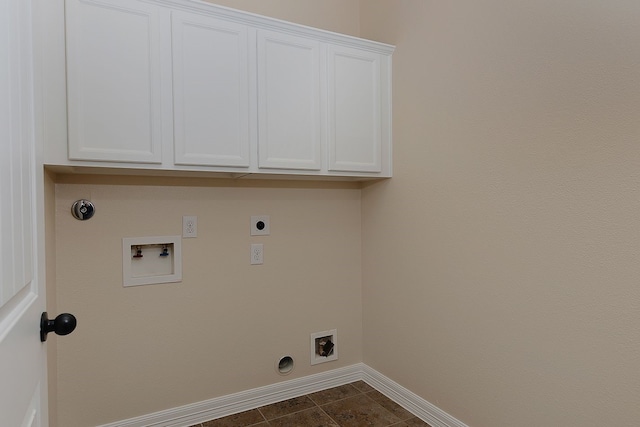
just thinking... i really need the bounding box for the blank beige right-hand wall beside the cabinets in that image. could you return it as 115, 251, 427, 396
361, 0, 640, 427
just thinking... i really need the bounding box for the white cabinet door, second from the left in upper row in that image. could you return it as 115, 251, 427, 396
172, 11, 250, 167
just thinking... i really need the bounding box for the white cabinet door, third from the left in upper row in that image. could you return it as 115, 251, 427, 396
258, 30, 322, 170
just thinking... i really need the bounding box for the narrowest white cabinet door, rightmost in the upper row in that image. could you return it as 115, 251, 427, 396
328, 46, 382, 172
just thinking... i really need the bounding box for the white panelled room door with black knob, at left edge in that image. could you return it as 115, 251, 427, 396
0, 0, 48, 427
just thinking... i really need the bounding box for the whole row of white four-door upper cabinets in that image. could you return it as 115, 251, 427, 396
35, 0, 394, 180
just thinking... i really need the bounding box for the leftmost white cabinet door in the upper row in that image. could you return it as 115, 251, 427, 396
66, 0, 162, 163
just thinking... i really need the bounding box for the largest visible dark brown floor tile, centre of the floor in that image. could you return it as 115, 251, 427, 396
322, 394, 402, 427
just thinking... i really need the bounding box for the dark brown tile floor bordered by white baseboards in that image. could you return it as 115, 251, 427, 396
191, 381, 430, 427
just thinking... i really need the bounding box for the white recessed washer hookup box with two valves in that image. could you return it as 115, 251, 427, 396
122, 236, 182, 287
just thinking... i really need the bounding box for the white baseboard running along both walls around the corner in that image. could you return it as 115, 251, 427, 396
98, 363, 468, 427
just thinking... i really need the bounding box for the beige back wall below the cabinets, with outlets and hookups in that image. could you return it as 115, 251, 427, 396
56, 177, 362, 427
